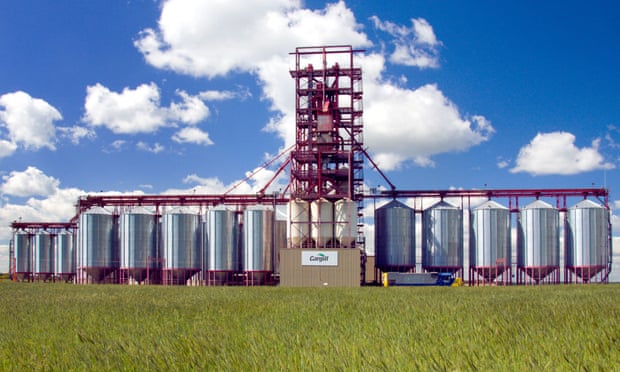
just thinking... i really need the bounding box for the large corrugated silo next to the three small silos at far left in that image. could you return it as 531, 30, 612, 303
77, 207, 120, 283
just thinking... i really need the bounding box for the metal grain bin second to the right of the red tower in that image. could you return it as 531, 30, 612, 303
422, 201, 463, 273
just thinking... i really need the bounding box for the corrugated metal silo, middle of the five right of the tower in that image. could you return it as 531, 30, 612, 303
469, 200, 512, 284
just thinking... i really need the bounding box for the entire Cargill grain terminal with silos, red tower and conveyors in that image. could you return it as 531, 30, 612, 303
10, 46, 611, 287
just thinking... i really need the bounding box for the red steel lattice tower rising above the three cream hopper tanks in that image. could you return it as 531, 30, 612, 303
290, 46, 364, 202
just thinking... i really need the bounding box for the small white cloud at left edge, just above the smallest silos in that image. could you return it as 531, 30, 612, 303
0, 167, 60, 197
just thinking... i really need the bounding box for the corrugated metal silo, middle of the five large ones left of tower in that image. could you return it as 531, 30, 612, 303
161, 208, 202, 285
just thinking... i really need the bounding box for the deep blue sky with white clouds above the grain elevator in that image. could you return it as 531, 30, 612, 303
0, 0, 620, 281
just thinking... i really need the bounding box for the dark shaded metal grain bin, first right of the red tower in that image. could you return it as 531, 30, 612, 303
375, 200, 415, 272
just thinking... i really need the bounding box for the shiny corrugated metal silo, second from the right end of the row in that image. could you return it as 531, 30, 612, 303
517, 200, 560, 284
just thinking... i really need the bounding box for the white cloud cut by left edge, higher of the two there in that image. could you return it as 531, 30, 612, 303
0, 91, 62, 150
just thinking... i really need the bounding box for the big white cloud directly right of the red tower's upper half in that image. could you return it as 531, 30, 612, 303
364, 81, 494, 170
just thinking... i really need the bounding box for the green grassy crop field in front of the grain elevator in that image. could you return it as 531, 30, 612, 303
0, 282, 620, 371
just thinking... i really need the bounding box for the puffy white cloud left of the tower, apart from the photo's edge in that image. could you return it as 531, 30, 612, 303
82, 83, 209, 134
